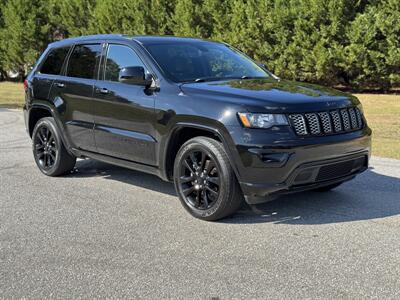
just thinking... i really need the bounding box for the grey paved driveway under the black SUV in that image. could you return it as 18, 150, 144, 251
0, 109, 400, 299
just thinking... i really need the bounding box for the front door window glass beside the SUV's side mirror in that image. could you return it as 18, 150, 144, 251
104, 44, 145, 81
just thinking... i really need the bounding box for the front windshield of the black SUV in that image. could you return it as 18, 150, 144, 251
145, 42, 269, 82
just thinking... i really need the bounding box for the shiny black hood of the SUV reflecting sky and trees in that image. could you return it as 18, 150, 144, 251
181, 78, 359, 112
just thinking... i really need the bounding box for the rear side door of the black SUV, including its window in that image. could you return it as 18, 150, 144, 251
51, 43, 102, 151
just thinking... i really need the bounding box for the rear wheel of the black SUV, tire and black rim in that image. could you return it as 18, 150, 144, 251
32, 117, 76, 176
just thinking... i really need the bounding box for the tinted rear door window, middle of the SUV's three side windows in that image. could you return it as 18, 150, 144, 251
67, 44, 101, 79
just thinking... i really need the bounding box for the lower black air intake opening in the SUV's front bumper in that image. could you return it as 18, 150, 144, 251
316, 156, 366, 182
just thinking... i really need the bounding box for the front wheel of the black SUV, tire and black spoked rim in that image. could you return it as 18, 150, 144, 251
174, 137, 243, 221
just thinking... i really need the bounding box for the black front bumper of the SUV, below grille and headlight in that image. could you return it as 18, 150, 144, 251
225, 127, 371, 204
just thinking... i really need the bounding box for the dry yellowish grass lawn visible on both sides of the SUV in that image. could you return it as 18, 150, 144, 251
0, 82, 400, 159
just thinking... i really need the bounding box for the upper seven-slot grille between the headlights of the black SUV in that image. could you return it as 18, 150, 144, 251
289, 107, 364, 136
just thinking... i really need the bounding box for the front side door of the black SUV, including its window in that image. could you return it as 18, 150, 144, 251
94, 44, 156, 165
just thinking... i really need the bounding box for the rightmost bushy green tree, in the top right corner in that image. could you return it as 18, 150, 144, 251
345, 0, 400, 90
